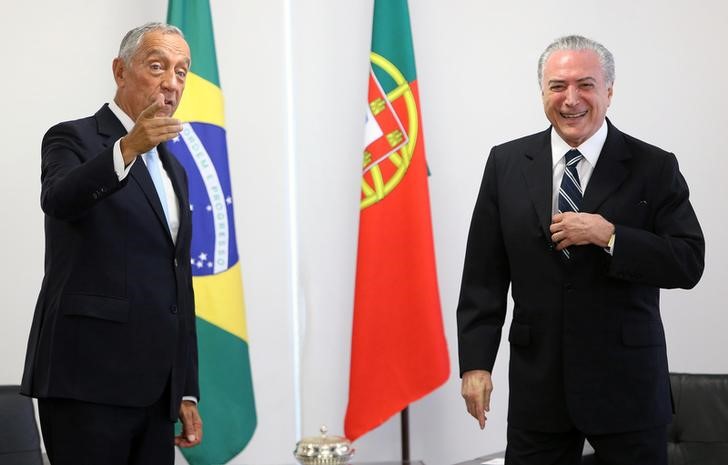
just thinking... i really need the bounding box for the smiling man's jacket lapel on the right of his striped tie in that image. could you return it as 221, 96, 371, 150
581, 120, 632, 213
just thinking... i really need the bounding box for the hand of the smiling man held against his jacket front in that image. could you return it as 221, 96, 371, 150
550, 212, 614, 250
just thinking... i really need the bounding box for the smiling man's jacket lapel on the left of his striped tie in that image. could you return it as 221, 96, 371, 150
523, 128, 553, 238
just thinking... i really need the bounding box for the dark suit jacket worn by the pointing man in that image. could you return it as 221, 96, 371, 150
22, 105, 199, 418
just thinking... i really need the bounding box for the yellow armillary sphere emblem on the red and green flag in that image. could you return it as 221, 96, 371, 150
360, 52, 419, 210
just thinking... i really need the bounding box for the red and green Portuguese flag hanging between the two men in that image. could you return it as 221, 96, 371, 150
344, 0, 450, 440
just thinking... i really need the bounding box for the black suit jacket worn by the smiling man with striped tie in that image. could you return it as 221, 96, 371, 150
457, 122, 705, 434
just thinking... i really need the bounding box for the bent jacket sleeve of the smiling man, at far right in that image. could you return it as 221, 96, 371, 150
608, 153, 705, 289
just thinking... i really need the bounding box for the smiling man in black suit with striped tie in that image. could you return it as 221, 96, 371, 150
457, 36, 705, 465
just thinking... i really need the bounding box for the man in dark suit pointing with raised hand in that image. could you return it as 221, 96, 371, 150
22, 23, 202, 465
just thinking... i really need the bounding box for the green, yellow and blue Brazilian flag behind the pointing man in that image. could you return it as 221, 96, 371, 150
167, 0, 256, 465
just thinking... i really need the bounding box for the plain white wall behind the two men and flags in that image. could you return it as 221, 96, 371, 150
0, 0, 728, 465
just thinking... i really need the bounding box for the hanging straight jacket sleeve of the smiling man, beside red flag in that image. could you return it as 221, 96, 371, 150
457, 148, 510, 376
